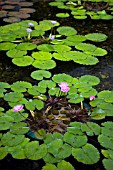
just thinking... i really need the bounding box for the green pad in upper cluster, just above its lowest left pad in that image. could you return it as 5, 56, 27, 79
6, 48, 27, 58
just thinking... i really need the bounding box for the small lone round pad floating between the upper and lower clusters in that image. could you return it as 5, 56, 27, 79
31, 70, 51, 80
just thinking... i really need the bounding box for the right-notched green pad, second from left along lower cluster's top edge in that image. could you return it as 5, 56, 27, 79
11, 81, 32, 92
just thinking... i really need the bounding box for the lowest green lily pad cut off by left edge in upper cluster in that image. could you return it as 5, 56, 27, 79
0, 42, 17, 50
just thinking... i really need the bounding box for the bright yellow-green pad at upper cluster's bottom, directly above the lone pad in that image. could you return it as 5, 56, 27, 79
32, 60, 56, 70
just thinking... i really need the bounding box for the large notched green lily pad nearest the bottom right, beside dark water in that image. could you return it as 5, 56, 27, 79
72, 143, 100, 164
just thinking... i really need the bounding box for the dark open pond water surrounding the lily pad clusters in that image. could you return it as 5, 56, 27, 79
0, 0, 113, 170
